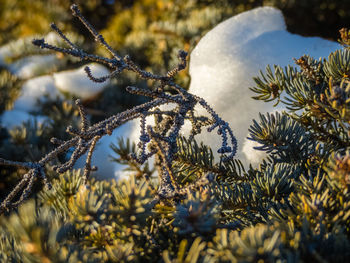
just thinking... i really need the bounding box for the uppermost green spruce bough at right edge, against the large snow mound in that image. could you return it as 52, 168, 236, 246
251, 45, 350, 153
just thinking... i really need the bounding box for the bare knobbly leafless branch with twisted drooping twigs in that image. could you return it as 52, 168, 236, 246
0, 4, 237, 213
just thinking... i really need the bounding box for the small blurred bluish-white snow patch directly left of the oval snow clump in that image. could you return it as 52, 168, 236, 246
14, 75, 62, 112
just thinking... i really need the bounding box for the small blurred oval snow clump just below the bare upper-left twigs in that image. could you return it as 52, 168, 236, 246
53, 63, 110, 99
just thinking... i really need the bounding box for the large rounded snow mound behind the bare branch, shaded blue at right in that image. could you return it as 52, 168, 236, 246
189, 7, 340, 165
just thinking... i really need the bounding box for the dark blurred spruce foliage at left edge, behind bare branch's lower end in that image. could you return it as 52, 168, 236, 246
0, 100, 78, 201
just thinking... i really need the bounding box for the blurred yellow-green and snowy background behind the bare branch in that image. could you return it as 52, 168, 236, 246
0, 0, 350, 198
